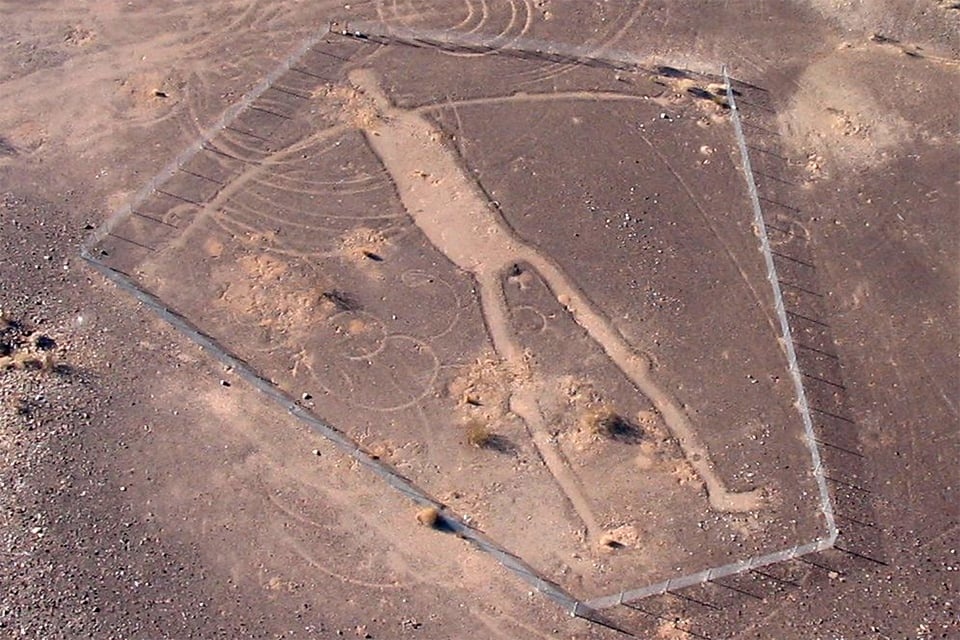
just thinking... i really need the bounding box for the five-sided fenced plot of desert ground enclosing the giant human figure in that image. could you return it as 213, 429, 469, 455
87, 28, 833, 607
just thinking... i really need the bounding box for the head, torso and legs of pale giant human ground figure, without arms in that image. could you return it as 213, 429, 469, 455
350, 69, 763, 524
